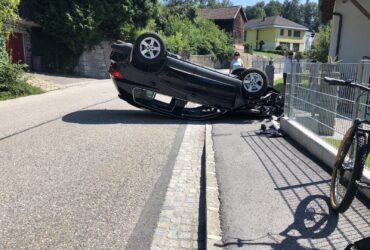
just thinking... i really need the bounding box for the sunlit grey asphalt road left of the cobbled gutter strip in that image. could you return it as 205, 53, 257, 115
0, 80, 185, 249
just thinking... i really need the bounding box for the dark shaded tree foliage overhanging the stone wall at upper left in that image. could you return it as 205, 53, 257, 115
22, 0, 157, 55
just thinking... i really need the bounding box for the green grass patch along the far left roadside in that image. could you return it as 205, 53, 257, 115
0, 81, 44, 101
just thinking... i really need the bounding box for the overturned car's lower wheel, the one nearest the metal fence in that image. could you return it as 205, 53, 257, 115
239, 69, 268, 97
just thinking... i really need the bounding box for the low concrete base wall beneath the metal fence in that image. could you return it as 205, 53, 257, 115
280, 117, 370, 199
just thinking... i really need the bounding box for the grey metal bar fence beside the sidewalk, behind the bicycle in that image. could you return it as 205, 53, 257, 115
285, 61, 370, 147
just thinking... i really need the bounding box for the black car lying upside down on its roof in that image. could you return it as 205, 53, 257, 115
109, 32, 284, 120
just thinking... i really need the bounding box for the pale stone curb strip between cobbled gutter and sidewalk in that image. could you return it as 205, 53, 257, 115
204, 123, 222, 250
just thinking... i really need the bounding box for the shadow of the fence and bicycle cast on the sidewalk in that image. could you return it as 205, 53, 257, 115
216, 132, 370, 249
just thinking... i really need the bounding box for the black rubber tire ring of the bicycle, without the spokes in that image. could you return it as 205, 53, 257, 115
330, 127, 368, 213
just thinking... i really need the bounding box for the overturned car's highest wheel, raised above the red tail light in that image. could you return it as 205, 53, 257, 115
133, 32, 167, 65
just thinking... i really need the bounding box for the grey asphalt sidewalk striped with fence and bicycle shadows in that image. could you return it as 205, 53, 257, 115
207, 115, 370, 249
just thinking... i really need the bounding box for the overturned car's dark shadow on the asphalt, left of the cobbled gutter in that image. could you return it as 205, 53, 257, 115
62, 109, 184, 125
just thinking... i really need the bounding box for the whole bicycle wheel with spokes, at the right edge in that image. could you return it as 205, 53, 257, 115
330, 127, 367, 213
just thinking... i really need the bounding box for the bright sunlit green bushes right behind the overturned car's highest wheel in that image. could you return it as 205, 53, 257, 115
140, 1, 233, 60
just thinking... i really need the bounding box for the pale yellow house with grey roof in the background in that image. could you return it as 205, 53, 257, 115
245, 16, 308, 51
